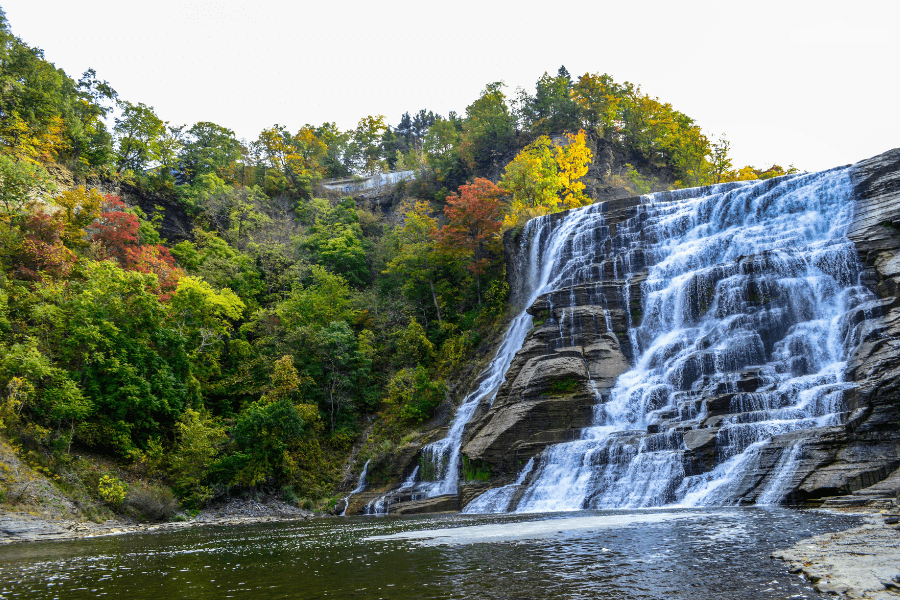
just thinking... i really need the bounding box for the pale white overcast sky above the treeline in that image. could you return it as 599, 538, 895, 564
0, 0, 900, 171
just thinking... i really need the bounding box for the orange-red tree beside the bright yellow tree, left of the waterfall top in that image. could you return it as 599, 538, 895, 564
439, 177, 503, 304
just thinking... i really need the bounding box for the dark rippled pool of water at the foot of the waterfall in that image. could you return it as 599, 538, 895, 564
0, 508, 859, 600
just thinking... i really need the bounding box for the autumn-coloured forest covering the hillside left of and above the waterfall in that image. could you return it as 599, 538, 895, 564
0, 11, 784, 516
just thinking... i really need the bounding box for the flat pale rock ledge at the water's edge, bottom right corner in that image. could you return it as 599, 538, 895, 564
772, 508, 900, 600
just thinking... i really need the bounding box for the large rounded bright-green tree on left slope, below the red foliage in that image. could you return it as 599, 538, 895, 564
33, 261, 199, 455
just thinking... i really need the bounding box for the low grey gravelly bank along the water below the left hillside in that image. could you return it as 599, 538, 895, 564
0, 499, 324, 545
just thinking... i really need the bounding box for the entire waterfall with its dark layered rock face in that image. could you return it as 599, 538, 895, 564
348, 150, 900, 512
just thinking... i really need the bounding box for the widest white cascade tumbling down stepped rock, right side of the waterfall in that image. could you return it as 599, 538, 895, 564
506, 168, 871, 512
